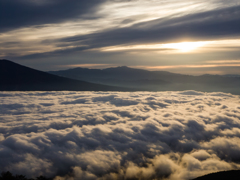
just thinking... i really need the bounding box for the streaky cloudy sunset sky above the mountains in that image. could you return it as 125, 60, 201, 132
0, 0, 240, 75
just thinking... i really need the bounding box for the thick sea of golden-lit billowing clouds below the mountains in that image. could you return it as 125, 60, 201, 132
0, 91, 240, 180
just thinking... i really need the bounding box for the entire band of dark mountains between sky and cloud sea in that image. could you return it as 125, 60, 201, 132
0, 59, 240, 94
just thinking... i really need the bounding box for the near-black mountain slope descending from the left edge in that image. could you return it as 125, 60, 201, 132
0, 60, 129, 91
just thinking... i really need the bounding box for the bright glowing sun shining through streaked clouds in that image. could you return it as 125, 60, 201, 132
163, 41, 207, 52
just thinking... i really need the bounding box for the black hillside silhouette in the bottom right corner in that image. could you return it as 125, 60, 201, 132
193, 170, 240, 180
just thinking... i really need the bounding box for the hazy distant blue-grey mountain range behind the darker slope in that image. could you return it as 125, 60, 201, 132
49, 66, 240, 94
